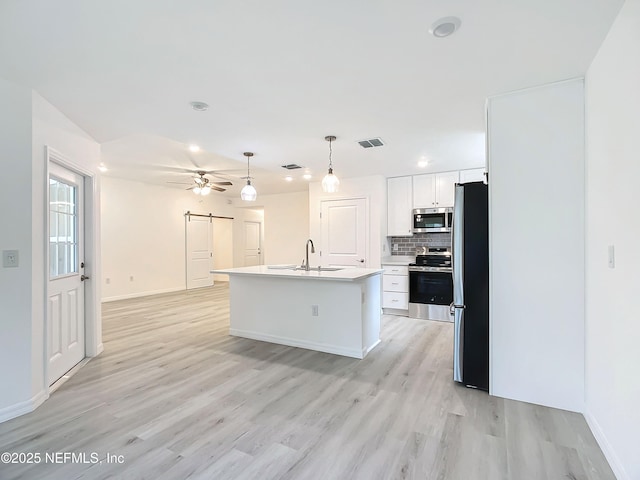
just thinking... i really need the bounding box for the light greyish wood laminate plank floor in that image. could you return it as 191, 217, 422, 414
0, 285, 615, 480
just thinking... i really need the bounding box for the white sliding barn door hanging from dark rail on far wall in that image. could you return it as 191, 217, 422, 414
185, 215, 213, 289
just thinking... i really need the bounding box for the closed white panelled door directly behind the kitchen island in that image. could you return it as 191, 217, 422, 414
320, 198, 367, 268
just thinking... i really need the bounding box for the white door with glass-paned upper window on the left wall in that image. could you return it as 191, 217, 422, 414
47, 163, 87, 385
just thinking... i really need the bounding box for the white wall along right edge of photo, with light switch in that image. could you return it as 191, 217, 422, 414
585, 0, 640, 480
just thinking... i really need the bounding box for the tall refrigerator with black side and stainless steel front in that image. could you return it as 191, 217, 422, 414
451, 182, 489, 392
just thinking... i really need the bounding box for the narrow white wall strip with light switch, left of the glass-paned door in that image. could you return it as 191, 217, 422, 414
0, 79, 35, 421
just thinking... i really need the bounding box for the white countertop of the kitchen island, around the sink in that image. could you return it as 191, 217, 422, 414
211, 265, 383, 282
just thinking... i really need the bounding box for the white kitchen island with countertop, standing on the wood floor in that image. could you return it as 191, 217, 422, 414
213, 265, 382, 358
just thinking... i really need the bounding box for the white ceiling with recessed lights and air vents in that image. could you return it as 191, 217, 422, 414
0, 0, 623, 196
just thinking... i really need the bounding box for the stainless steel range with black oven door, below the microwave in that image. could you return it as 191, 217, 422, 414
409, 247, 453, 322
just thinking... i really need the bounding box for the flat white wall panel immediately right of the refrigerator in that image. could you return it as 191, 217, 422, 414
488, 79, 584, 412
